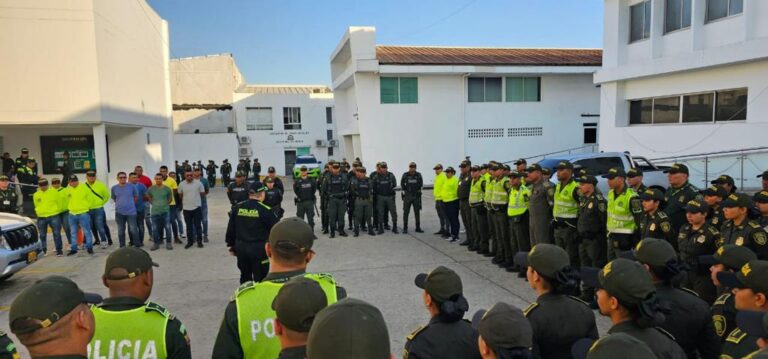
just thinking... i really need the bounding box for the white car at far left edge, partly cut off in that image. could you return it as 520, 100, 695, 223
0, 213, 42, 281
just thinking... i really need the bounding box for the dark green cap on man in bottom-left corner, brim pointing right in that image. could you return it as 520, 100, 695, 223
8, 275, 102, 335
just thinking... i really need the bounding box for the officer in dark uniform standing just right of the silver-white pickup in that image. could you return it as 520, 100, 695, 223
664, 163, 702, 233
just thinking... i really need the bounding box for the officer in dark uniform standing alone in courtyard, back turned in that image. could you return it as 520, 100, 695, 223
226, 187, 278, 284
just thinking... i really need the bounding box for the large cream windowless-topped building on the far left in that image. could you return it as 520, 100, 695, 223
0, 0, 173, 183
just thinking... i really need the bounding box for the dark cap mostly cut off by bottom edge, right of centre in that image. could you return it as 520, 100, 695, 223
571, 333, 657, 359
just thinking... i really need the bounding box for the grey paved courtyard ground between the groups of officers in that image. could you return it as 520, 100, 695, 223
0, 182, 609, 358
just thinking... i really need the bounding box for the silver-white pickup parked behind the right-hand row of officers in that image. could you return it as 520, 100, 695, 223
539, 152, 669, 194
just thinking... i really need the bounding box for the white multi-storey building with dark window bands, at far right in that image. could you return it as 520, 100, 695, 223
595, 0, 768, 187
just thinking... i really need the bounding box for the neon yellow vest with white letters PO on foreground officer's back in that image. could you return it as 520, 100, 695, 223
235, 274, 337, 359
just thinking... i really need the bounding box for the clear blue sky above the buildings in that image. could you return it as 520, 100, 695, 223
148, 0, 603, 85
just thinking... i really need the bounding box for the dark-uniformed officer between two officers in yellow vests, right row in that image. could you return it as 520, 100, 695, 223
575, 175, 608, 300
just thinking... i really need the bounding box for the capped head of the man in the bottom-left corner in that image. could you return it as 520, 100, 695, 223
8, 276, 101, 358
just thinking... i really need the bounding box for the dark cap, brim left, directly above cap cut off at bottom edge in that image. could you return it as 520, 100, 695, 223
581, 258, 656, 304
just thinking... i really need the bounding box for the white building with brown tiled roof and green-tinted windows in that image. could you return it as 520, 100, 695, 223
331, 27, 602, 182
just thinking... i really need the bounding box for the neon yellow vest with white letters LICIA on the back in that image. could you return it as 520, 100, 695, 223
89, 302, 171, 359
